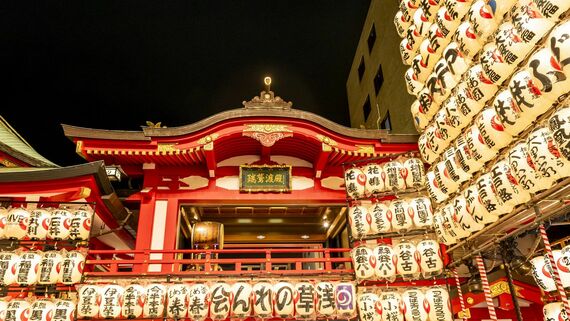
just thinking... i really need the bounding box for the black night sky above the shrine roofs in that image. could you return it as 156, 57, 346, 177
0, 0, 370, 165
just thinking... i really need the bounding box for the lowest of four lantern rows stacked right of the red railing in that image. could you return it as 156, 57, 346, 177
358, 287, 453, 321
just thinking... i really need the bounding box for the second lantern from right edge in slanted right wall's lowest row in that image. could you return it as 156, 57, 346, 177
526, 127, 570, 180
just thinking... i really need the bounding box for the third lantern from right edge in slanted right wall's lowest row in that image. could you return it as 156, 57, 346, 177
508, 141, 553, 193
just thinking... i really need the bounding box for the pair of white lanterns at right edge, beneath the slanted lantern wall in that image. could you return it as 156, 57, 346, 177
530, 245, 570, 292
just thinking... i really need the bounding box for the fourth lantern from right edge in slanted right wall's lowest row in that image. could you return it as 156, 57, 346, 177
491, 160, 530, 209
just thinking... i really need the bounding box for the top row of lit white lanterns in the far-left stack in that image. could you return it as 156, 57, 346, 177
0, 207, 92, 241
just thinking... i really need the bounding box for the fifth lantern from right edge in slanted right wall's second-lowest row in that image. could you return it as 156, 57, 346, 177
476, 108, 513, 151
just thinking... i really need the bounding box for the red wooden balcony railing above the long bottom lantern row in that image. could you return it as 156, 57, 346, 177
84, 248, 354, 278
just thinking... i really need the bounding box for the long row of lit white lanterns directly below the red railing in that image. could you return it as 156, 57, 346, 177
77, 281, 357, 321
